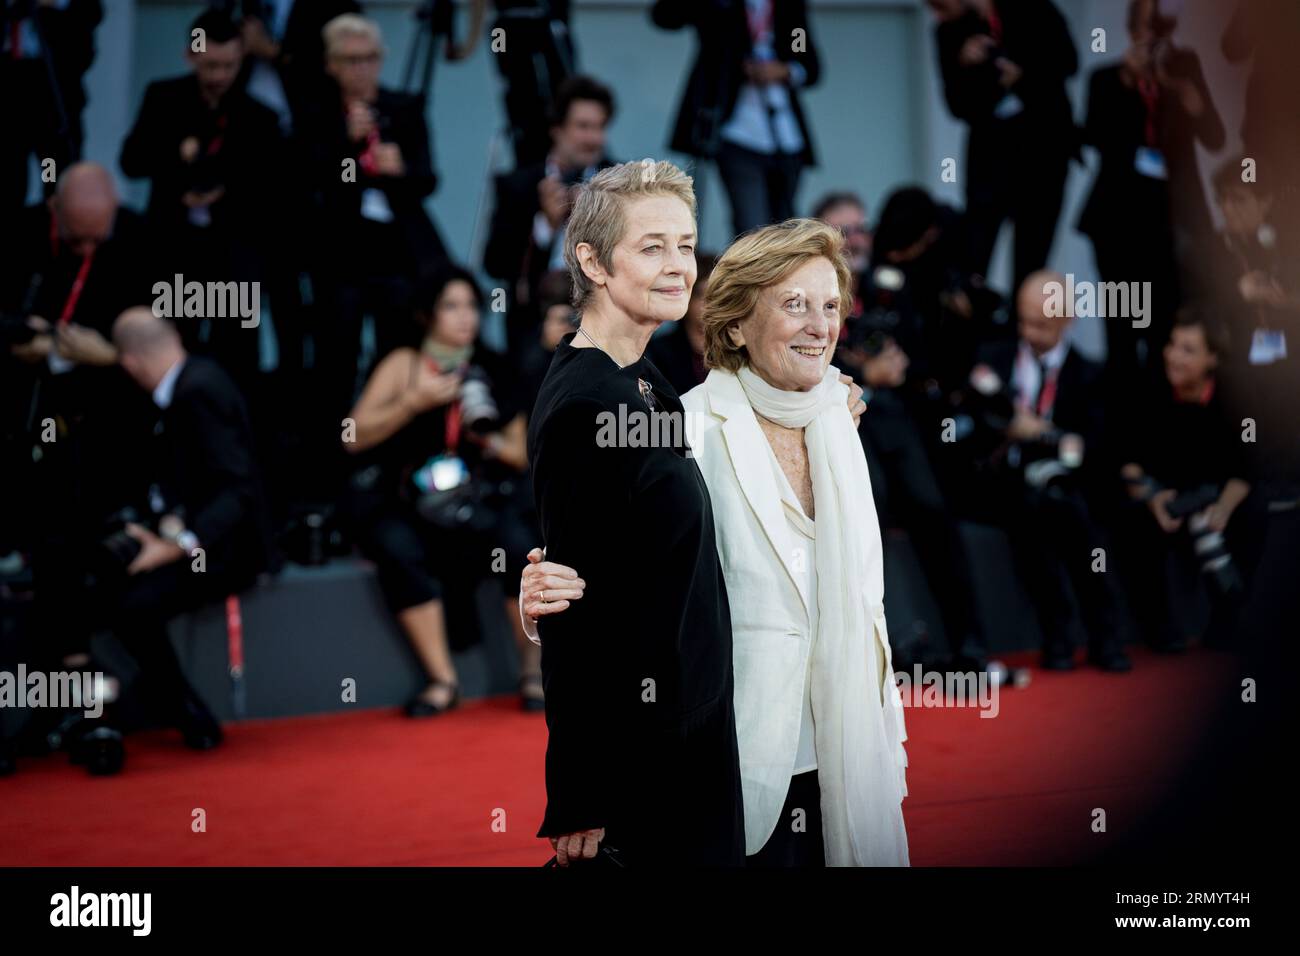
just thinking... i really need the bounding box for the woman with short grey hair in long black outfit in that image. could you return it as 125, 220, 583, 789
528, 160, 745, 866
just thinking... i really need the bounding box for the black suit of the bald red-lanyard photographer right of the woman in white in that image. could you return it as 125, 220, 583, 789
975, 342, 1122, 658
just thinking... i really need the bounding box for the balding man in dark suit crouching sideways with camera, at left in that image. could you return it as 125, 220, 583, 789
36, 307, 272, 774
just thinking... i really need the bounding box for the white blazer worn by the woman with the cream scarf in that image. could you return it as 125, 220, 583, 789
681, 369, 907, 865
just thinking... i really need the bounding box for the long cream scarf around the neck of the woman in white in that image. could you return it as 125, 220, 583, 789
738, 365, 909, 866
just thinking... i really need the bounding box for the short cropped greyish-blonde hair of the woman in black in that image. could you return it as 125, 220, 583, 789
564, 159, 696, 311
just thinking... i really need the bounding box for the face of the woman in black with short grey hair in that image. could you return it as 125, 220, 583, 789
605, 195, 696, 323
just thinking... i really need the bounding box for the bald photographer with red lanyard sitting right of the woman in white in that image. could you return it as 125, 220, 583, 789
967, 272, 1131, 671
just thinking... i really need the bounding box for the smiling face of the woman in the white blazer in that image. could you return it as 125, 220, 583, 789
731, 256, 842, 392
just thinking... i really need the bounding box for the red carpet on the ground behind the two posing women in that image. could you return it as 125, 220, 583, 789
0, 650, 1239, 866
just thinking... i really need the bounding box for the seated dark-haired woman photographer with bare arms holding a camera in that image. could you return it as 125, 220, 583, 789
343, 267, 542, 717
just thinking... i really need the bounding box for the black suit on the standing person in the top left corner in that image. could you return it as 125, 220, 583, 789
0, 0, 104, 213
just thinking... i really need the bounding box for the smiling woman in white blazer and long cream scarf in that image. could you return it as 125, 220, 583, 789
523, 220, 909, 866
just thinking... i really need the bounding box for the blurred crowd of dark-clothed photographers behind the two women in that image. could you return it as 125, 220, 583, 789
0, 0, 1300, 773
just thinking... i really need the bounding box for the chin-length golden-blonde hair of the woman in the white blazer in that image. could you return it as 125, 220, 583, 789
703, 219, 853, 372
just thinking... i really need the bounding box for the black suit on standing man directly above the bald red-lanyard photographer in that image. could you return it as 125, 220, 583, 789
935, 0, 1078, 286
